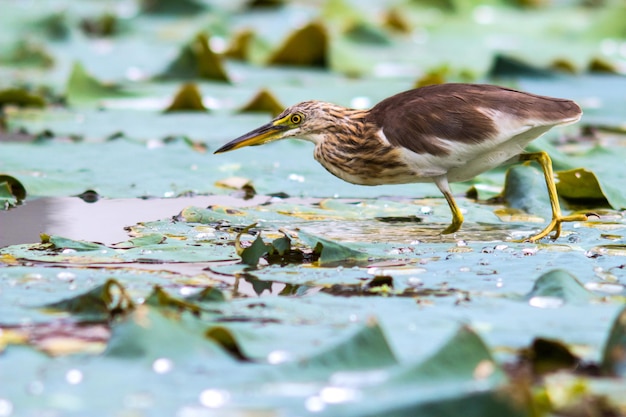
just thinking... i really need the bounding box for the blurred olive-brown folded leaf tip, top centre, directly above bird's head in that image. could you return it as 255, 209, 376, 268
268, 22, 328, 67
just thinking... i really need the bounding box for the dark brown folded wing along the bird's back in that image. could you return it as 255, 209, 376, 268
368, 84, 581, 156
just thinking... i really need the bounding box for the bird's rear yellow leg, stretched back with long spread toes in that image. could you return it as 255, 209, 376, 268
520, 152, 587, 242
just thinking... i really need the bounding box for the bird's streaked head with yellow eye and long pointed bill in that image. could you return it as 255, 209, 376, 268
214, 100, 346, 153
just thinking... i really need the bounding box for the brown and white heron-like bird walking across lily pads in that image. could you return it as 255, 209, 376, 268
214, 83, 587, 242
